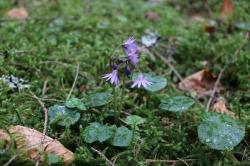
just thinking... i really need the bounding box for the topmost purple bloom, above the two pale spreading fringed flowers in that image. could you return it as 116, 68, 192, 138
123, 37, 139, 64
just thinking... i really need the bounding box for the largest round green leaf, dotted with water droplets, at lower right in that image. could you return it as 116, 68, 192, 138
198, 113, 245, 150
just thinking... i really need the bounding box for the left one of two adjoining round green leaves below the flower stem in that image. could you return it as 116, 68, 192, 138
84, 122, 113, 143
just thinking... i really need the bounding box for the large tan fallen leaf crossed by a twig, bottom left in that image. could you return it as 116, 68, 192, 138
0, 125, 74, 163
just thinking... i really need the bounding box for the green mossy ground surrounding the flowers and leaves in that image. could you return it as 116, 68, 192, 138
0, 0, 250, 165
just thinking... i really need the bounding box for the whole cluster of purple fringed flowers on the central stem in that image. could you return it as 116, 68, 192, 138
103, 37, 151, 88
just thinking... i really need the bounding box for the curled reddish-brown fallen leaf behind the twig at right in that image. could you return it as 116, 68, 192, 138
178, 69, 224, 96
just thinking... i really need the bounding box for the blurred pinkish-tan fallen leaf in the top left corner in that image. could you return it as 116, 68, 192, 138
6, 7, 29, 20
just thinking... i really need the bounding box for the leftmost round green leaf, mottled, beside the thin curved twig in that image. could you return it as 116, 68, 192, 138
48, 105, 80, 126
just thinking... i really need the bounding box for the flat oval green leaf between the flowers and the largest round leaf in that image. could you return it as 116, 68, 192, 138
159, 96, 194, 112
